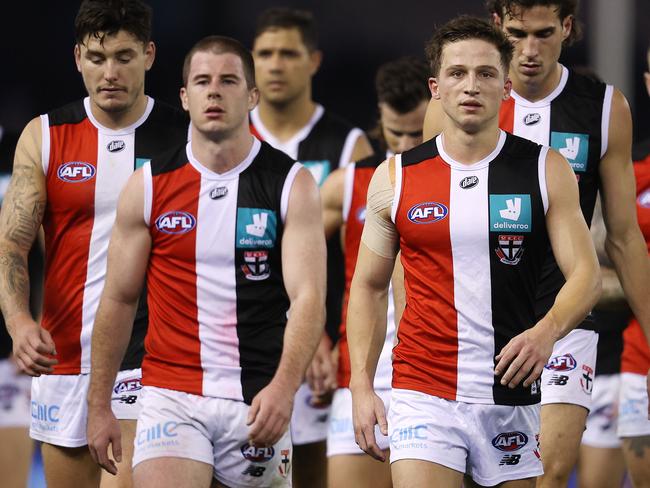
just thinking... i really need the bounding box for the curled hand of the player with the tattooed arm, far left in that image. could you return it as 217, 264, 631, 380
9, 315, 58, 376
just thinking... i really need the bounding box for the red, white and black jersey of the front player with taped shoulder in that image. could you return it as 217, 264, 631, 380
392, 132, 549, 405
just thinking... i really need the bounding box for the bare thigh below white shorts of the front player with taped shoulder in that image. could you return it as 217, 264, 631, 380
390, 459, 463, 488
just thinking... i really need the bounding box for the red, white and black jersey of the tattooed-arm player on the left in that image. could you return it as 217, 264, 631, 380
41, 98, 188, 374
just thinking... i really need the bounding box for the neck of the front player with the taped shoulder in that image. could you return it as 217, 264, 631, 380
442, 123, 501, 165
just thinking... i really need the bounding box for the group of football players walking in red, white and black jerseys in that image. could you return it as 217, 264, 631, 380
0, 0, 650, 487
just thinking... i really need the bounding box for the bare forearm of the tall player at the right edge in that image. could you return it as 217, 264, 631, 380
605, 232, 650, 342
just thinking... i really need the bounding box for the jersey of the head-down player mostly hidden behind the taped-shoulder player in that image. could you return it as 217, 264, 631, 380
337, 153, 395, 390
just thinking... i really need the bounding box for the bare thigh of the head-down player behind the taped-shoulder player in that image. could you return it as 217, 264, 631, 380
327, 450, 392, 488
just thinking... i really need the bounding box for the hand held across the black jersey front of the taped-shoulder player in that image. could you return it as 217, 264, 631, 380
494, 324, 555, 388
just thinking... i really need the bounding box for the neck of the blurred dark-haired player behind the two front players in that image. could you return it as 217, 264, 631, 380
258, 91, 316, 142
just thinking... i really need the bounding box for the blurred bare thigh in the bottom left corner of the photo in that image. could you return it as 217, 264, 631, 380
0, 427, 34, 488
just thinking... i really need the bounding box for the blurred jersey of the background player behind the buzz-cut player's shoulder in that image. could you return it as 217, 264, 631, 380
250, 104, 363, 339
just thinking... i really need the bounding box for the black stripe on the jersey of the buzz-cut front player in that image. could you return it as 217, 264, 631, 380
233, 142, 292, 404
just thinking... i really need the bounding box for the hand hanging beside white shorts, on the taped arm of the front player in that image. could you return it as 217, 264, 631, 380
351, 387, 388, 462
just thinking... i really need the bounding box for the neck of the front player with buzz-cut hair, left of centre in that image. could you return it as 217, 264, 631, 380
191, 125, 253, 174
